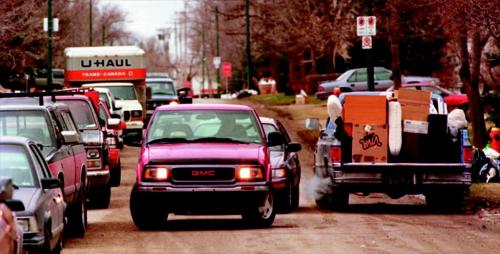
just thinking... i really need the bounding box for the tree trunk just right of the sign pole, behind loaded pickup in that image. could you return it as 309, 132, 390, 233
390, 6, 401, 90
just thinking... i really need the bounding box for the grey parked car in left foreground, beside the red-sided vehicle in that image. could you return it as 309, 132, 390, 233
0, 137, 66, 253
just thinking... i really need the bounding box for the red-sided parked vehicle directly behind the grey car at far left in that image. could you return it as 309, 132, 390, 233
0, 93, 87, 236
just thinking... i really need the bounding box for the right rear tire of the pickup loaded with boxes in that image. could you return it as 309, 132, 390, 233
425, 189, 465, 213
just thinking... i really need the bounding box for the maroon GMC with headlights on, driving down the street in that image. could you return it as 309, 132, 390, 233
130, 104, 286, 229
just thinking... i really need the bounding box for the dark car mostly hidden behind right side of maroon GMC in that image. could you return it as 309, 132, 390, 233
260, 117, 302, 211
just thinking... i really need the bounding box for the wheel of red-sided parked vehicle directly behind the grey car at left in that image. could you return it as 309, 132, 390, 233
68, 190, 87, 237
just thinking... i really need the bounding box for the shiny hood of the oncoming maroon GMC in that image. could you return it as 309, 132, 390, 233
145, 143, 265, 164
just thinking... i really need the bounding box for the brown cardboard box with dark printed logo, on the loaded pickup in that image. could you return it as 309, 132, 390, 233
352, 124, 388, 162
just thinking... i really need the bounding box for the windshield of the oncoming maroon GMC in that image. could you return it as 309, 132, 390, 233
147, 110, 262, 144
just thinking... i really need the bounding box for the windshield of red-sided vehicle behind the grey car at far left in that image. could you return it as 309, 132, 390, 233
0, 110, 56, 147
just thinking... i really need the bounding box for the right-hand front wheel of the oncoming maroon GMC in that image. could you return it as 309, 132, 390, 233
241, 191, 276, 228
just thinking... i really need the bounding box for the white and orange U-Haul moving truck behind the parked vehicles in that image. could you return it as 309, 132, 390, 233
64, 46, 146, 142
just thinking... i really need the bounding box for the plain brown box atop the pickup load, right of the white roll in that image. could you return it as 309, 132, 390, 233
395, 88, 432, 121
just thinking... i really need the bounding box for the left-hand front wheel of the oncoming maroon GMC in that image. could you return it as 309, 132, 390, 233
130, 185, 168, 230
